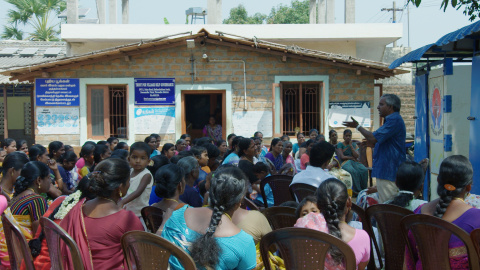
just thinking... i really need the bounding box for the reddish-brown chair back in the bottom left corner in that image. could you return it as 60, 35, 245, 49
2, 214, 35, 270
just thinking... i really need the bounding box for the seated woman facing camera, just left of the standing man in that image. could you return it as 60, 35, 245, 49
336, 129, 368, 193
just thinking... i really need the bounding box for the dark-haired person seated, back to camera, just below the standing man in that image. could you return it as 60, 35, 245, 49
384, 160, 427, 211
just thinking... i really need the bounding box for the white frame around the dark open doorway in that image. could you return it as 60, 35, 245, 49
175, 84, 233, 139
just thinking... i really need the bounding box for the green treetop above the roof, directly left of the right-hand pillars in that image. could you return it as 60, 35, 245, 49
267, 0, 310, 24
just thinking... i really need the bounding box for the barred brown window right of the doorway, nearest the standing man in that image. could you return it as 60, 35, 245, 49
281, 82, 322, 136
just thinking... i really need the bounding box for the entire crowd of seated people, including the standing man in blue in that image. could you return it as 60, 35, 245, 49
0, 95, 480, 269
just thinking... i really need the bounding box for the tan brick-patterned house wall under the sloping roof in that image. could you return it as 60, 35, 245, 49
36, 44, 374, 145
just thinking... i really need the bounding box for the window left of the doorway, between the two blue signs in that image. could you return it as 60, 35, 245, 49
87, 85, 128, 140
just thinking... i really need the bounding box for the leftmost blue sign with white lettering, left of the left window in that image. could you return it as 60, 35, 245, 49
35, 79, 80, 106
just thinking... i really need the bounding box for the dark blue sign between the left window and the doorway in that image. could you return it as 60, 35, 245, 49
134, 78, 175, 105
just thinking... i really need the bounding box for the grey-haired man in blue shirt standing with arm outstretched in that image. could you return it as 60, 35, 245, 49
343, 94, 406, 203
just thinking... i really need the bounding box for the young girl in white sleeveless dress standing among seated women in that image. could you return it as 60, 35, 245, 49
119, 142, 153, 222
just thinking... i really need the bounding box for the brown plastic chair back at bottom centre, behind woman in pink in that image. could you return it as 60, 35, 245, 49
260, 228, 356, 270
